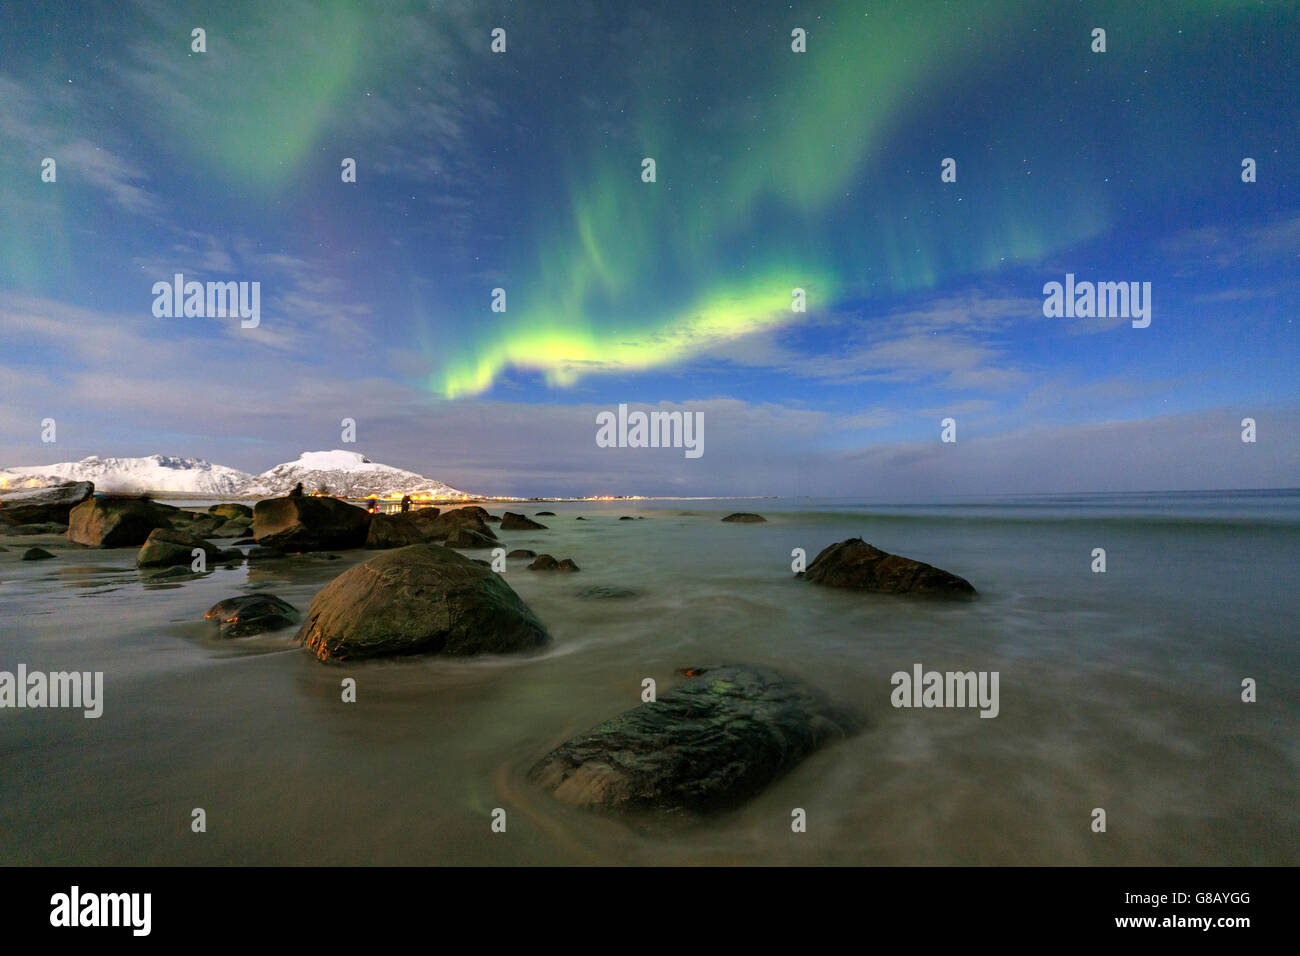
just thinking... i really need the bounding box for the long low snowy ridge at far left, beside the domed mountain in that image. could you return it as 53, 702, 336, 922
0, 455, 252, 497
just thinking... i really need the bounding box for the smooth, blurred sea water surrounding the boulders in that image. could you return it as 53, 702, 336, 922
0, 490, 1300, 865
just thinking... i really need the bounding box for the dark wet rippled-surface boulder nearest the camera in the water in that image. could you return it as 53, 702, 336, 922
528, 666, 858, 812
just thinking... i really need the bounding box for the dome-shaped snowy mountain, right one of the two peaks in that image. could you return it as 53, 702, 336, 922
243, 449, 469, 498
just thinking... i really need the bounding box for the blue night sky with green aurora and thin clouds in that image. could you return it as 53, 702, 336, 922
0, 0, 1300, 497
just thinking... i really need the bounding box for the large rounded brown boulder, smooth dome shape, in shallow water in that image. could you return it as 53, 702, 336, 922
298, 544, 549, 661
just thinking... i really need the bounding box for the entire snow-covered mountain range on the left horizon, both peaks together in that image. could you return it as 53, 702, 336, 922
0, 450, 471, 498
